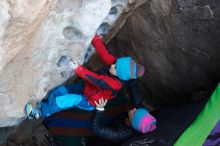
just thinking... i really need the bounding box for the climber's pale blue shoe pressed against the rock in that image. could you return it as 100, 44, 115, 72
25, 103, 40, 119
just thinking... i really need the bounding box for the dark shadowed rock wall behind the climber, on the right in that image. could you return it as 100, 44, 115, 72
109, 0, 220, 107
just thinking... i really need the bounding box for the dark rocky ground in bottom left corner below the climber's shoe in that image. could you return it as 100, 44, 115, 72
0, 120, 50, 146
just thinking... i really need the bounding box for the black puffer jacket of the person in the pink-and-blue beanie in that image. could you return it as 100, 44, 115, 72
91, 80, 143, 142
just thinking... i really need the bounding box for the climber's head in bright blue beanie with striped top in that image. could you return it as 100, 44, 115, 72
109, 57, 144, 80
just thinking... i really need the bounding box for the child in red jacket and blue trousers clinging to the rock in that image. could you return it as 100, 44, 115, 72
25, 35, 144, 119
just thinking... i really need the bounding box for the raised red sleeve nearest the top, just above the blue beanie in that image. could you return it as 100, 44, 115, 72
92, 34, 116, 65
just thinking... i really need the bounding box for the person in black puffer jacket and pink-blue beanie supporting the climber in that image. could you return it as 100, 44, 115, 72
88, 98, 156, 142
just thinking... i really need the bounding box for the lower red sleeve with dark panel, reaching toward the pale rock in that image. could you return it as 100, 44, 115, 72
75, 65, 122, 90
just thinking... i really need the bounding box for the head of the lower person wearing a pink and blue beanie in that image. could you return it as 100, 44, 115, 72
128, 108, 156, 133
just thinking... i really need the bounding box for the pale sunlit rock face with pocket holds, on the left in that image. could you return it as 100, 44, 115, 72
0, 0, 146, 127
